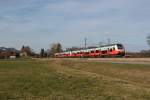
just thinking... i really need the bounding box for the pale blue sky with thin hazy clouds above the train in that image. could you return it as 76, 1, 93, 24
0, 0, 150, 51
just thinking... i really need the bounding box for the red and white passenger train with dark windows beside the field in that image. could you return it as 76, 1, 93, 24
55, 44, 125, 58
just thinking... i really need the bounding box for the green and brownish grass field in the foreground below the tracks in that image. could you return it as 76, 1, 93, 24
0, 59, 150, 100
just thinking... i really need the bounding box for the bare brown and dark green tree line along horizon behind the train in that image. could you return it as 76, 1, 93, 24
0, 35, 150, 59
